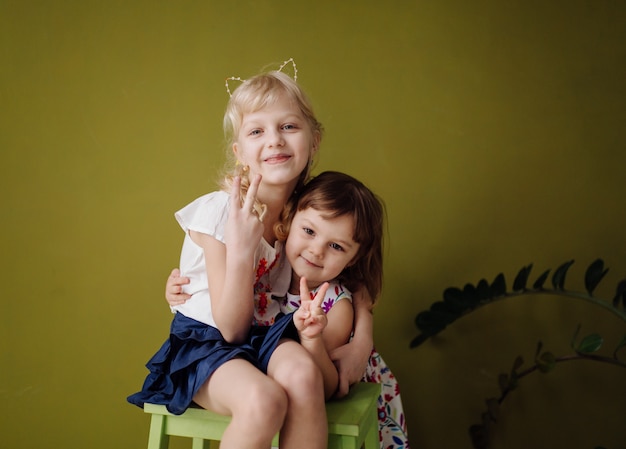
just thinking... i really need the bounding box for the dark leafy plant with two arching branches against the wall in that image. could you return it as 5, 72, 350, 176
410, 259, 626, 449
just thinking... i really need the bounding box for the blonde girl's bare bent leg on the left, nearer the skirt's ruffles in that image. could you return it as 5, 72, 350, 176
194, 359, 288, 449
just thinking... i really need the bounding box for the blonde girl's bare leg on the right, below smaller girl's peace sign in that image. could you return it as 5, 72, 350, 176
268, 340, 328, 449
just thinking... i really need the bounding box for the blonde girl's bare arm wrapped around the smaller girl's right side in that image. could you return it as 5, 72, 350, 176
331, 288, 374, 397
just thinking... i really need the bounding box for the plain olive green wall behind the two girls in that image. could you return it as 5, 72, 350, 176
0, 0, 626, 449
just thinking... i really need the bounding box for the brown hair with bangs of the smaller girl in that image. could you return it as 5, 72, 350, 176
275, 171, 385, 302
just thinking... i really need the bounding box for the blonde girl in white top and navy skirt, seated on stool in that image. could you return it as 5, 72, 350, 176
129, 64, 327, 449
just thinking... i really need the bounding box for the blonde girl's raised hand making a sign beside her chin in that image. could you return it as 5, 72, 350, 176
226, 175, 265, 259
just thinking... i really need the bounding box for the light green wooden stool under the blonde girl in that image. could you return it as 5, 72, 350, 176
144, 382, 380, 449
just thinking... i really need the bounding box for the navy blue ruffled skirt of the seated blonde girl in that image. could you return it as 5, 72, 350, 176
128, 313, 299, 415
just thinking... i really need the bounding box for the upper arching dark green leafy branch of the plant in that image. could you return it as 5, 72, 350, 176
410, 259, 626, 348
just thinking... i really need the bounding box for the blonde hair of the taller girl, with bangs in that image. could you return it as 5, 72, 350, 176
222, 71, 323, 209
